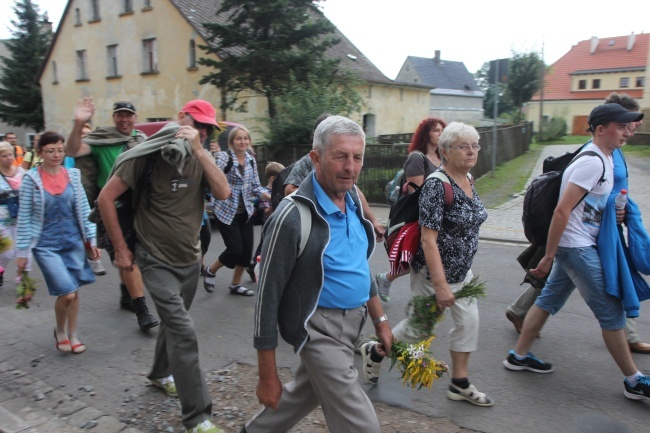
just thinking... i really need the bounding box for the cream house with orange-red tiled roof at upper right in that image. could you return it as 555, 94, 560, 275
526, 33, 650, 135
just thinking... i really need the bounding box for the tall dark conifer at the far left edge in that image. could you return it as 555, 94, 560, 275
0, 0, 52, 131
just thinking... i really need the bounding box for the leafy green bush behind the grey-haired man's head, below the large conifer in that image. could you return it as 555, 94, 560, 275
266, 74, 362, 146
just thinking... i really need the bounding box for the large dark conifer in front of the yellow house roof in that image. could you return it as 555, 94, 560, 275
198, 0, 339, 119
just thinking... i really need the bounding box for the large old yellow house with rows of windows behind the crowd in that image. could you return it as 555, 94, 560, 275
39, 0, 430, 142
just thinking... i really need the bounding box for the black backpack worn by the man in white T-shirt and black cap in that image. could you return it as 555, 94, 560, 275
521, 148, 605, 246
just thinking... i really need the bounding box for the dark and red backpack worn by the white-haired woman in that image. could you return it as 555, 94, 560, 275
384, 171, 474, 252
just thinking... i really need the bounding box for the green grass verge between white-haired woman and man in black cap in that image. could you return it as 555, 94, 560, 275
475, 144, 542, 209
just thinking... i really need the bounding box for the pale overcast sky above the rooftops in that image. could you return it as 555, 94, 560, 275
0, 0, 650, 79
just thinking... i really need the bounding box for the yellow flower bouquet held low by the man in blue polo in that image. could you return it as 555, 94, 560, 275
388, 336, 449, 389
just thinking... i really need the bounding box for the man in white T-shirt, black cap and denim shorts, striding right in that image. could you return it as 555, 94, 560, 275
503, 104, 650, 400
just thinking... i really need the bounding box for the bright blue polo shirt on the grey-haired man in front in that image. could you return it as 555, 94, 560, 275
312, 174, 370, 310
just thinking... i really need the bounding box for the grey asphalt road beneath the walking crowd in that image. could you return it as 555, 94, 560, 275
0, 231, 650, 433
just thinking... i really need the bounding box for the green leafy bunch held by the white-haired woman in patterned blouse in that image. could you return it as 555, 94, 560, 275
406, 275, 485, 339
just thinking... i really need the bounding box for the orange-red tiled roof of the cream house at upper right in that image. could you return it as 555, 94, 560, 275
533, 33, 650, 101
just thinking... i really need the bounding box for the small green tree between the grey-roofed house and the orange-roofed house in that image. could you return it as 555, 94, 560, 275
507, 51, 545, 121
